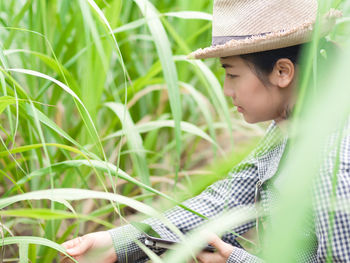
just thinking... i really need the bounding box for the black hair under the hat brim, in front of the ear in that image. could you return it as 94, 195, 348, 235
240, 44, 303, 86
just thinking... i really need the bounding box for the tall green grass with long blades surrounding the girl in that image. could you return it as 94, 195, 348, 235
0, 0, 350, 262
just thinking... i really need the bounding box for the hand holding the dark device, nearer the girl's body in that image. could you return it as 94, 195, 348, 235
191, 234, 234, 263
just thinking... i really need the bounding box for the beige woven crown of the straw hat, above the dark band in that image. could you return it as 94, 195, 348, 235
212, 0, 318, 36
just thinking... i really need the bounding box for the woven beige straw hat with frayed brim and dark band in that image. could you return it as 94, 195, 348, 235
189, 0, 342, 59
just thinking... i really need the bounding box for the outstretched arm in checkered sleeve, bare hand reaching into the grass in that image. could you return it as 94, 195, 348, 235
62, 122, 280, 262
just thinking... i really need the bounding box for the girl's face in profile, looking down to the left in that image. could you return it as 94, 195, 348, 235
220, 56, 294, 123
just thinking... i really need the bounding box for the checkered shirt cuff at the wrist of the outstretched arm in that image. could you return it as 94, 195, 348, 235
108, 225, 148, 263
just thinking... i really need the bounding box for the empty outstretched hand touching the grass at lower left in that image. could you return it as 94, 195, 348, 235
62, 231, 117, 263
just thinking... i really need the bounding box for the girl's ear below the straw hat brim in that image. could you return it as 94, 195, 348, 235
269, 58, 295, 88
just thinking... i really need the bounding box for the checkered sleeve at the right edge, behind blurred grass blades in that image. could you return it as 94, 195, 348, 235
315, 129, 350, 262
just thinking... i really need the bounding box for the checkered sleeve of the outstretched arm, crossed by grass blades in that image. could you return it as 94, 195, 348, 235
108, 157, 258, 262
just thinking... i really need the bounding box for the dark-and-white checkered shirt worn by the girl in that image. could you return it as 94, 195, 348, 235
108, 121, 350, 263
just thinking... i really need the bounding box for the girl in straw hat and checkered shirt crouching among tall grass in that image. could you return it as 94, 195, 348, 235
63, 0, 350, 263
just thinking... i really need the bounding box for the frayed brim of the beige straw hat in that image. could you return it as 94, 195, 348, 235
187, 9, 342, 59
